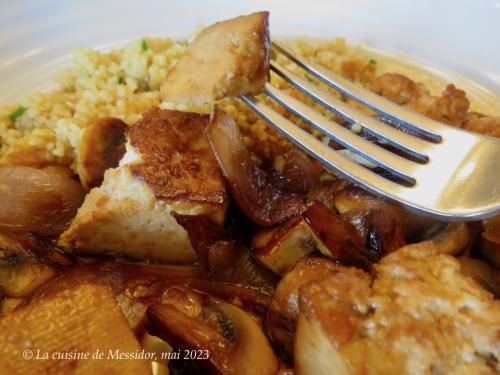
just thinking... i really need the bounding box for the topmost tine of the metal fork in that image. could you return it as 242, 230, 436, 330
272, 42, 443, 142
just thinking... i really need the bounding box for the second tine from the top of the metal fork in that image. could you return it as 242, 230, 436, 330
271, 63, 432, 162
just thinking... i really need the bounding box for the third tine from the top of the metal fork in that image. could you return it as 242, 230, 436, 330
262, 83, 416, 185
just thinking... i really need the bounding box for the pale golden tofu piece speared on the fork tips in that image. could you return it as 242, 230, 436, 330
161, 12, 271, 106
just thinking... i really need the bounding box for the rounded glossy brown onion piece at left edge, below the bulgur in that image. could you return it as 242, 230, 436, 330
0, 165, 84, 237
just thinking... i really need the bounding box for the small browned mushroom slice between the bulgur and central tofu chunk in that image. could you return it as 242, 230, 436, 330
77, 118, 127, 190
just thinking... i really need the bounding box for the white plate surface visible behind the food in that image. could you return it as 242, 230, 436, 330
0, 0, 500, 113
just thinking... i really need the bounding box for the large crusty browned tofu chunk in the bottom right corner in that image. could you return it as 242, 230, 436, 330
295, 242, 500, 374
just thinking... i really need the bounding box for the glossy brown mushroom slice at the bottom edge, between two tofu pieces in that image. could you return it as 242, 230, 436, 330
147, 290, 279, 375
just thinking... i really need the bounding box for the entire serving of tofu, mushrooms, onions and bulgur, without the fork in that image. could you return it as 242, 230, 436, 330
0, 12, 500, 375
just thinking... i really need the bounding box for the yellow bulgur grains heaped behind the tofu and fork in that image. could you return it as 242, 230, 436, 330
0, 38, 468, 171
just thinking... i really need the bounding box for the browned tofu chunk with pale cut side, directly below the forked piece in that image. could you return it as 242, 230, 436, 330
59, 108, 227, 263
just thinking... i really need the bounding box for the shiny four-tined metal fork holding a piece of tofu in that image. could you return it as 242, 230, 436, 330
240, 42, 500, 221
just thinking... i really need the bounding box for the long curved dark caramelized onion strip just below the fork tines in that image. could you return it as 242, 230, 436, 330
208, 106, 304, 226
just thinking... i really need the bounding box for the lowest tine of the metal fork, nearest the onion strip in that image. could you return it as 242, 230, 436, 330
240, 95, 411, 195
